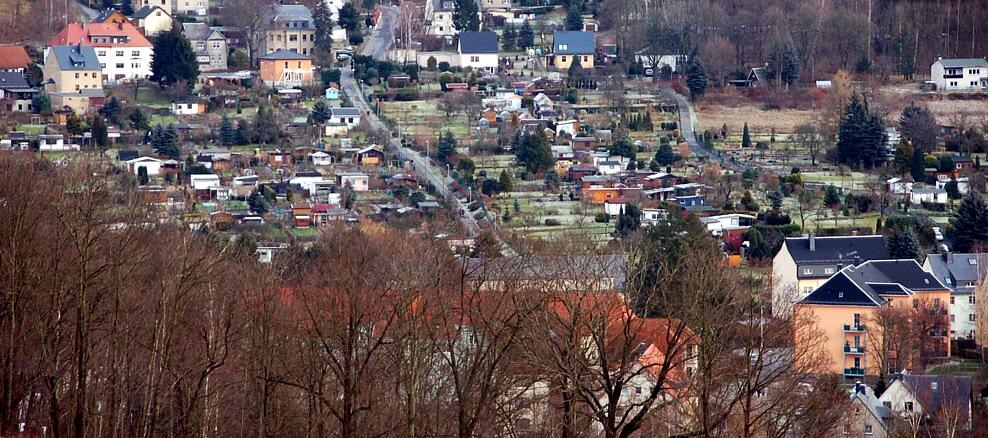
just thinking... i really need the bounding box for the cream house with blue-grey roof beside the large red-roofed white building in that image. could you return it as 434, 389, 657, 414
43, 44, 105, 114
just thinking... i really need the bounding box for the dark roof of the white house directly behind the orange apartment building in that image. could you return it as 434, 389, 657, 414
785, 236, 891, 265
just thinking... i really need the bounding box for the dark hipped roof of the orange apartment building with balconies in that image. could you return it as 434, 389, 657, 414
800, 259, 947, 306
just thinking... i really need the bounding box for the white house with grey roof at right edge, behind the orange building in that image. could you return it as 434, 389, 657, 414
923, 251, 988, 339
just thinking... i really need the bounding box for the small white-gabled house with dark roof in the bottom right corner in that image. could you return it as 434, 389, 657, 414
879, 374, 973, 436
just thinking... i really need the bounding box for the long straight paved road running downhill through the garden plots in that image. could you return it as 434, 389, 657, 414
340, 6, 480, 237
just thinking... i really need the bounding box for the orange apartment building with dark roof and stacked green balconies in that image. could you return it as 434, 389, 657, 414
794, 259, 950, 378
